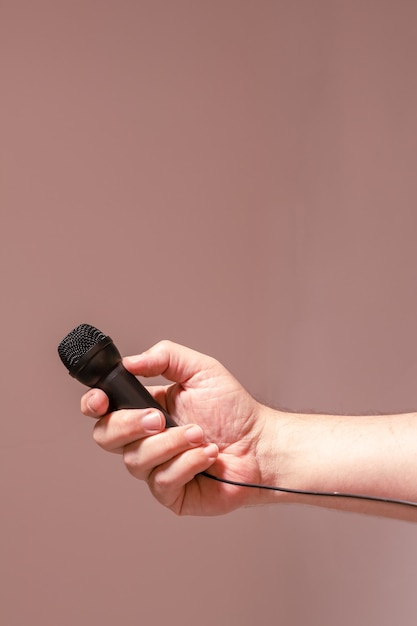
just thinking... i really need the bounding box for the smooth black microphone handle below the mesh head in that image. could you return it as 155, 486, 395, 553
94, 363, 176, 428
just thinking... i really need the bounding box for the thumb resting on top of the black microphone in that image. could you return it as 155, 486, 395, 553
123, 341, 216, 383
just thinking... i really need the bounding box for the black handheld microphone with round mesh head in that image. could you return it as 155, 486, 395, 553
58, 324, 176, 427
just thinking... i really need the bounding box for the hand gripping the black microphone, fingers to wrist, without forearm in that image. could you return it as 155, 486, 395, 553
81, 341, 271, 515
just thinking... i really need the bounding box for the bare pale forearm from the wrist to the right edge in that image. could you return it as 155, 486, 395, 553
261, 407, 417, 521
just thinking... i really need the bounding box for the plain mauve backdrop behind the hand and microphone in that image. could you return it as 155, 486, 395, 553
0, 0, 417, 626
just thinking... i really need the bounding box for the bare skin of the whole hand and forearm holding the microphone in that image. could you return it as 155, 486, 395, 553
81, 341, 417, 521
